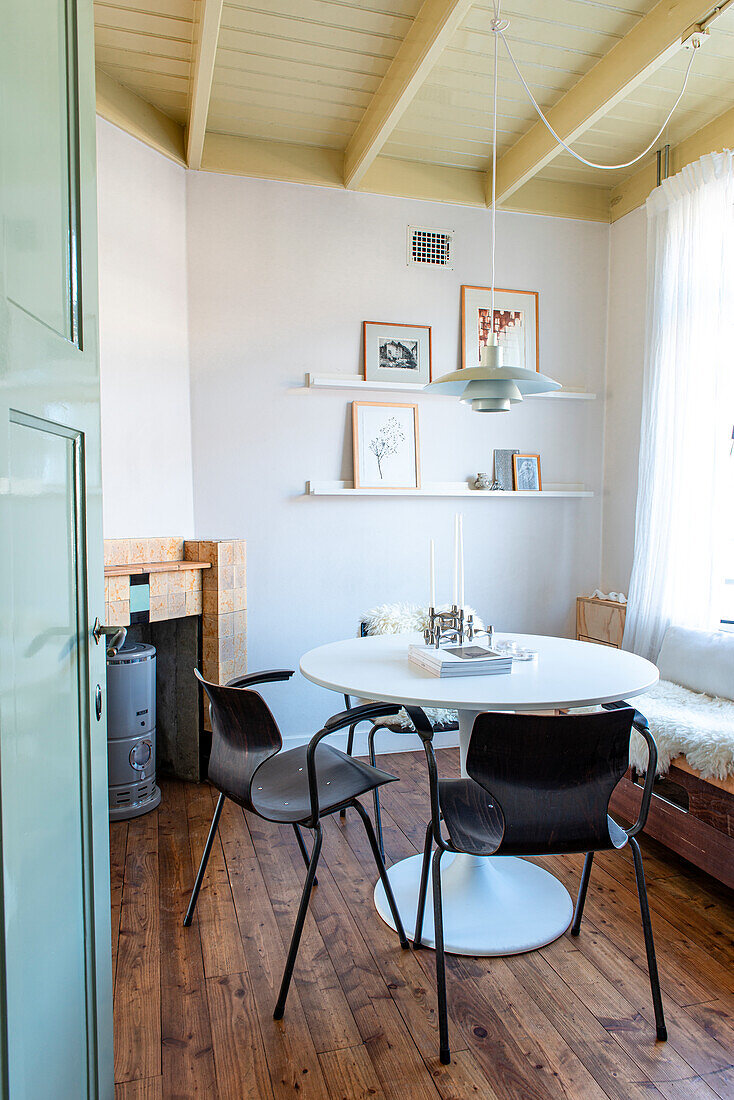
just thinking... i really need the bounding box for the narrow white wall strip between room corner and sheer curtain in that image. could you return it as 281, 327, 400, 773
602, 207, 646, 592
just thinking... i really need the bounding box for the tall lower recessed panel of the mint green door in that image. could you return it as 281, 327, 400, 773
5, 416, 94, 1097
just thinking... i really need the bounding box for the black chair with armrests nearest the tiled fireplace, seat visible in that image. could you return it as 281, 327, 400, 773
184, 669, 408, 1020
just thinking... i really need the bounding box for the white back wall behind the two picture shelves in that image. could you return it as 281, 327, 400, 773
187, 173, 609, 735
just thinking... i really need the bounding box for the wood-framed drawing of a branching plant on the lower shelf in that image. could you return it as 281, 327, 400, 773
352, 402, 420, 488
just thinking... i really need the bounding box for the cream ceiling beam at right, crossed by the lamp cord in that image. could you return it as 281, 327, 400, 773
487, 0, 715, 204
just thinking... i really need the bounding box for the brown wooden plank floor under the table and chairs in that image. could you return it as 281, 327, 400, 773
110, 749, 734, 1100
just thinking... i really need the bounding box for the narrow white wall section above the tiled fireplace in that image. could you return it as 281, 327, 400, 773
97, 119, 194, 538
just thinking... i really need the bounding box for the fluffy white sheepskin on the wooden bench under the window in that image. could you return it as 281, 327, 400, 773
629, 680, 734, 779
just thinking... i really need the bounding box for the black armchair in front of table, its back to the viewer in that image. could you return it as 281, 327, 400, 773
406, 703, 668, 1063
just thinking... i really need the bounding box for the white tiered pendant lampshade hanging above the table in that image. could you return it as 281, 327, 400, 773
424, 343, 561, 413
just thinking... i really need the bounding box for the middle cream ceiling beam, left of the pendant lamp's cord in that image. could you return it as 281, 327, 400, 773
344, 0, 472, 188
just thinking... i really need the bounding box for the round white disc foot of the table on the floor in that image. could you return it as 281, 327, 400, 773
374, 853, 573, 955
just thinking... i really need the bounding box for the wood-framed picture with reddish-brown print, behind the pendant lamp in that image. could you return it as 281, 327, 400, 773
461, 286, 540, 371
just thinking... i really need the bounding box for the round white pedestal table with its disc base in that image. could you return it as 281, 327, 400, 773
300, 635, 658, 955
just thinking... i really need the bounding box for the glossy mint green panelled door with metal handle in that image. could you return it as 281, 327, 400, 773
0, 0, 113, 1100
